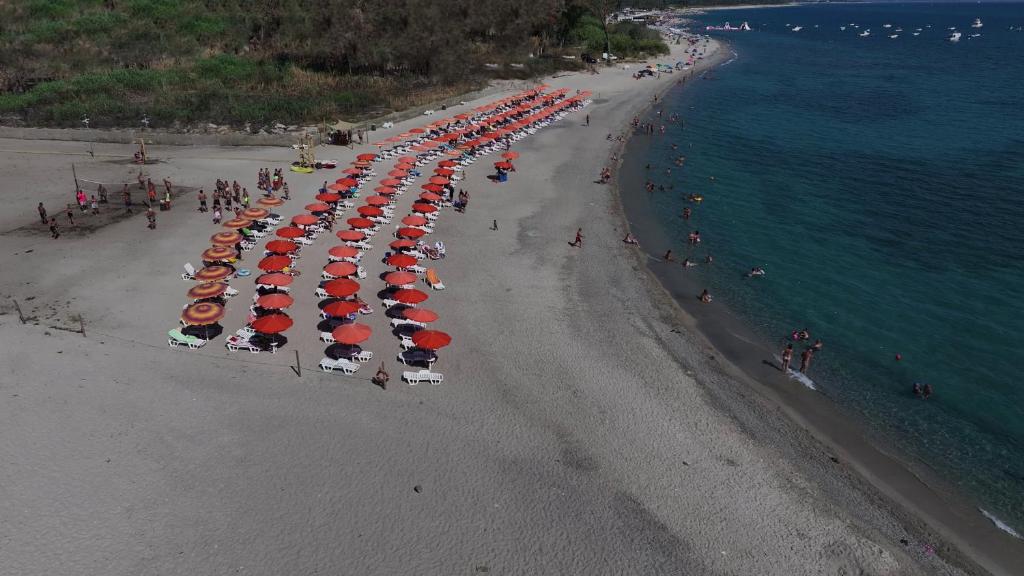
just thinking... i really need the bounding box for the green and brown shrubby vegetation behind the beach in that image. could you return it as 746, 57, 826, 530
0, 0, 668, 127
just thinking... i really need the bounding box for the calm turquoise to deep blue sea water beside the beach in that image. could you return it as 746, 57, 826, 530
624, 3, 1024, 532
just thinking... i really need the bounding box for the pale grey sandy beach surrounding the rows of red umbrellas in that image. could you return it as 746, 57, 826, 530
0, 36, 1014, 575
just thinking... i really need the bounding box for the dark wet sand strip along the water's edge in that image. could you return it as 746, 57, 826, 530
611, 39, 1024, 574
